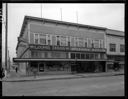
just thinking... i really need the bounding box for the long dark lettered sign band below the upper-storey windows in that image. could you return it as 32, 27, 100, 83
29, 45, 106, 52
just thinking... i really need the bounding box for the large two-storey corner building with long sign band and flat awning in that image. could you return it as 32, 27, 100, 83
13, 16, 123, 75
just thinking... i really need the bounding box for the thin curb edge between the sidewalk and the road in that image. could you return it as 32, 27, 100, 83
2, 73, 124, 82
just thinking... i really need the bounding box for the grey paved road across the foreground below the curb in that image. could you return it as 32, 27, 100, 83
3, 75, 124, 96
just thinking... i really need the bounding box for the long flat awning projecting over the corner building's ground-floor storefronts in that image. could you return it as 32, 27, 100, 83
13, 58, 107, 62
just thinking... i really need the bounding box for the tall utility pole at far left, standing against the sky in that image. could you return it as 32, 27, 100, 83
5, 3, 8, 71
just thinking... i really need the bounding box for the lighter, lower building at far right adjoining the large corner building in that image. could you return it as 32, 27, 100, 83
105, 29, 125, 70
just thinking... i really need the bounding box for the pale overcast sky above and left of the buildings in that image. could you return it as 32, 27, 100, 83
2, 3, 125, 61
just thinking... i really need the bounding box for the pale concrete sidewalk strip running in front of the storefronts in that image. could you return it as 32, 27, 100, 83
1, 71, 124, 82
